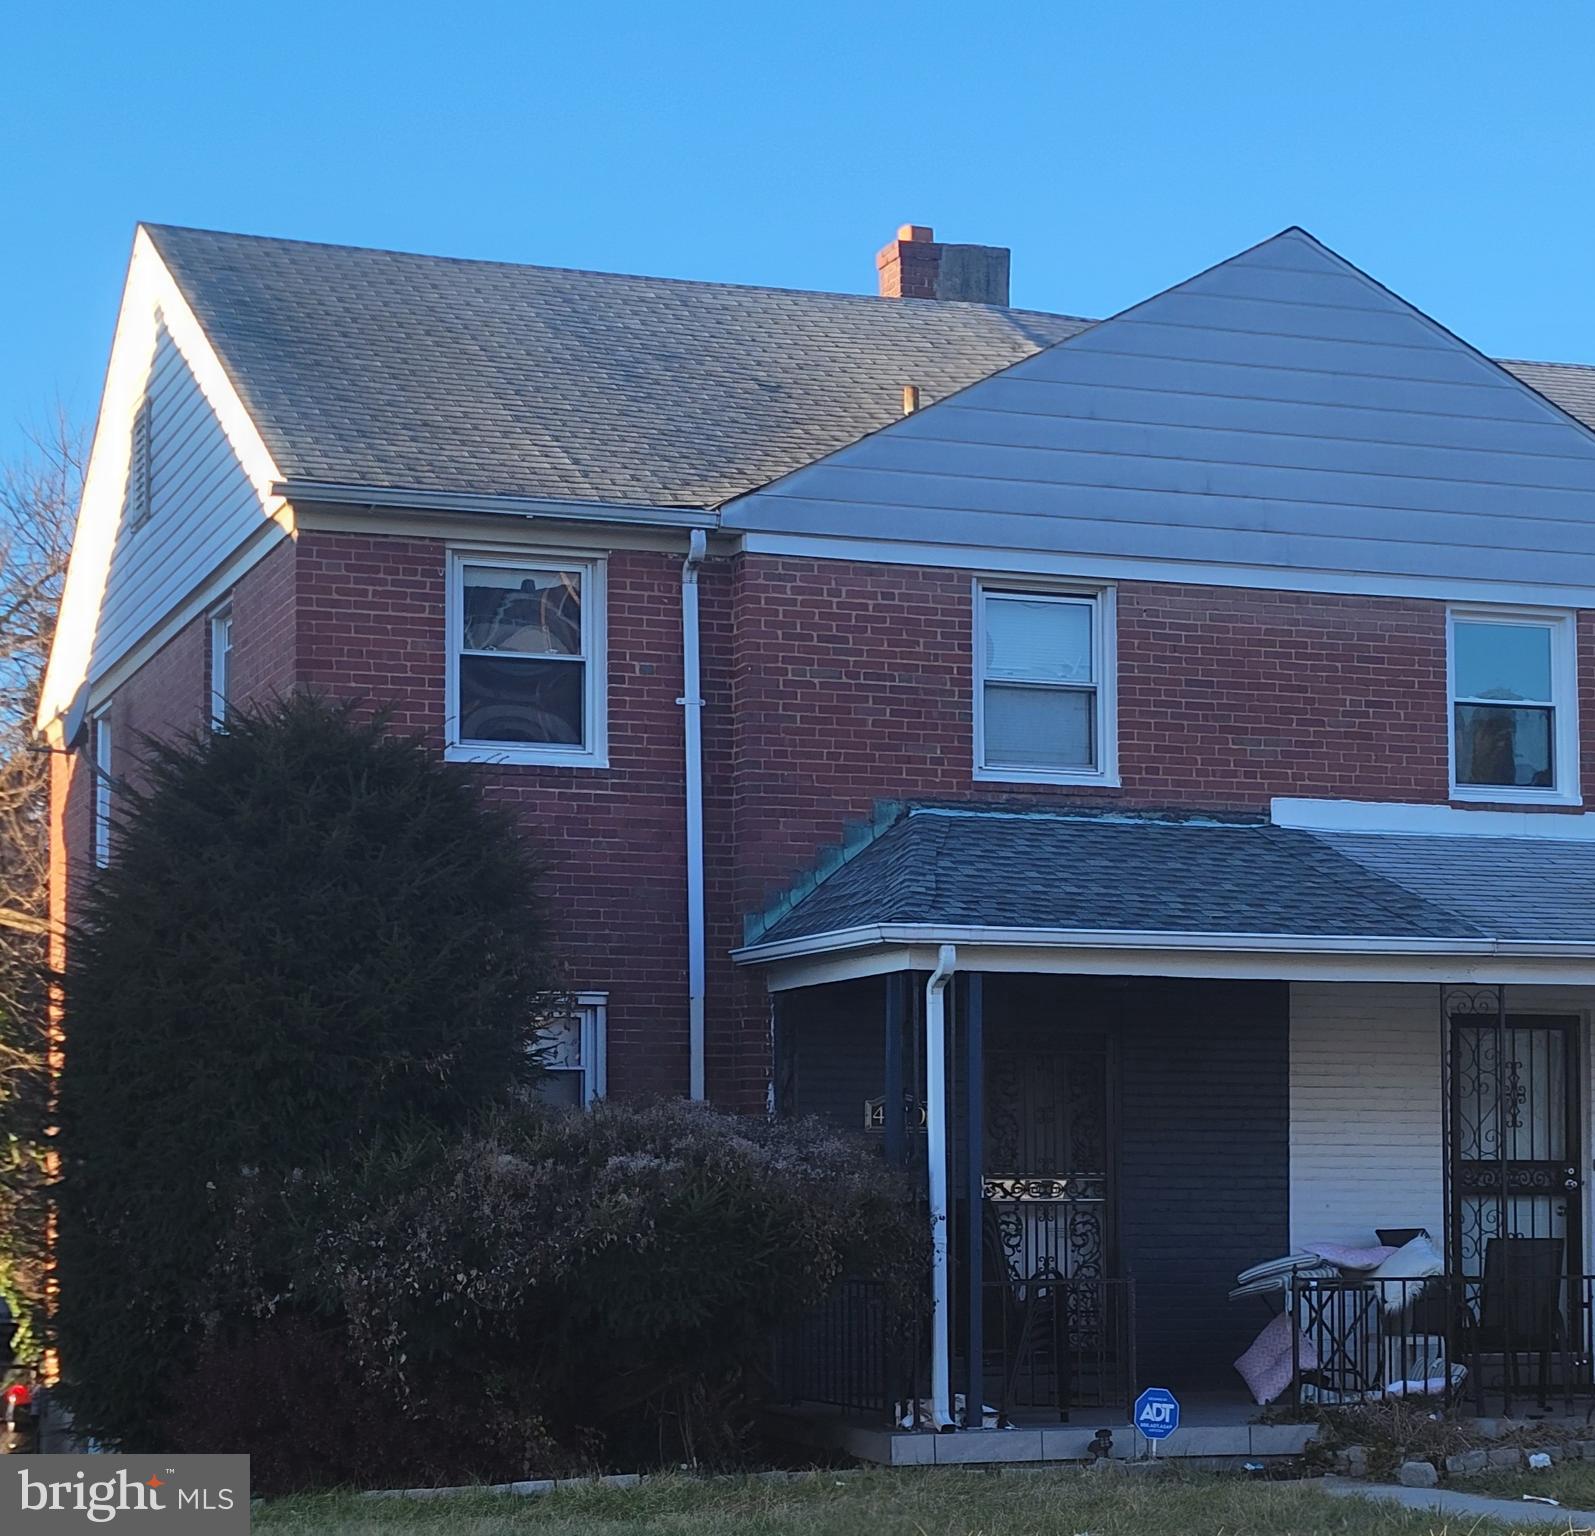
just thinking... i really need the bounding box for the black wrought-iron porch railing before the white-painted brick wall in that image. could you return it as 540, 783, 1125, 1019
1289, 1271, 1595, 1415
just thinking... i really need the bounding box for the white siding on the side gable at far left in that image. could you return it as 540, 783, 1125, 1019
89, 315, 281, 678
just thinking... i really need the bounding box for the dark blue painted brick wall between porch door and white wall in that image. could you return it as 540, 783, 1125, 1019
1118, 981, 1290, 1391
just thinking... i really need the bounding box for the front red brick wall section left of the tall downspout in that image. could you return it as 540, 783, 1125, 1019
295, 533, 687, 1096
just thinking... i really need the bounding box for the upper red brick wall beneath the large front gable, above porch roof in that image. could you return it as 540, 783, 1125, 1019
732, 555, 1595, 906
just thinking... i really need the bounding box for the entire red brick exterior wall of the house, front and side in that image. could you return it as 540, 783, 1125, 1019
56, 533, 1595, 1107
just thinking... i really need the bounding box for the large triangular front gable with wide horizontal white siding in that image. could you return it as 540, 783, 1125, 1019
724, 231, 1595, 595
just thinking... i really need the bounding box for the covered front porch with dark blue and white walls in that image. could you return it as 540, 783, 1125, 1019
759, 970, 1595, 1463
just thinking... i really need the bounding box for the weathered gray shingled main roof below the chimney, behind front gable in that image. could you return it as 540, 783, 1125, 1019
145, 225, 1595, 507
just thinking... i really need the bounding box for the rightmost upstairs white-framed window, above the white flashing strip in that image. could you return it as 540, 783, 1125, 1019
1447, 608, 1579, 805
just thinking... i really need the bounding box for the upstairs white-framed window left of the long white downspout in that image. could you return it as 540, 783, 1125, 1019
447, 549, 609, 767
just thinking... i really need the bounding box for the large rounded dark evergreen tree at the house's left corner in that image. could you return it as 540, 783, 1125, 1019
57, 695, 550, 1448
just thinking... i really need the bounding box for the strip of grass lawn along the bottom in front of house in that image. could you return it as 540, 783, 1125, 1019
254, 1467, 1554, 1536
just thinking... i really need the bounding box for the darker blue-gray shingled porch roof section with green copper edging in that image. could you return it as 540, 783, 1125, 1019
750, 809, 1492, 943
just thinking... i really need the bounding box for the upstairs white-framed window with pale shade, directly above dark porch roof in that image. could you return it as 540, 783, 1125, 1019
973, 581, 1118, 785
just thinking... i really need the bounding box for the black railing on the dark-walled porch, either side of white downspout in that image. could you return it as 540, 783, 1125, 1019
774, 1276, 1136, 1429
